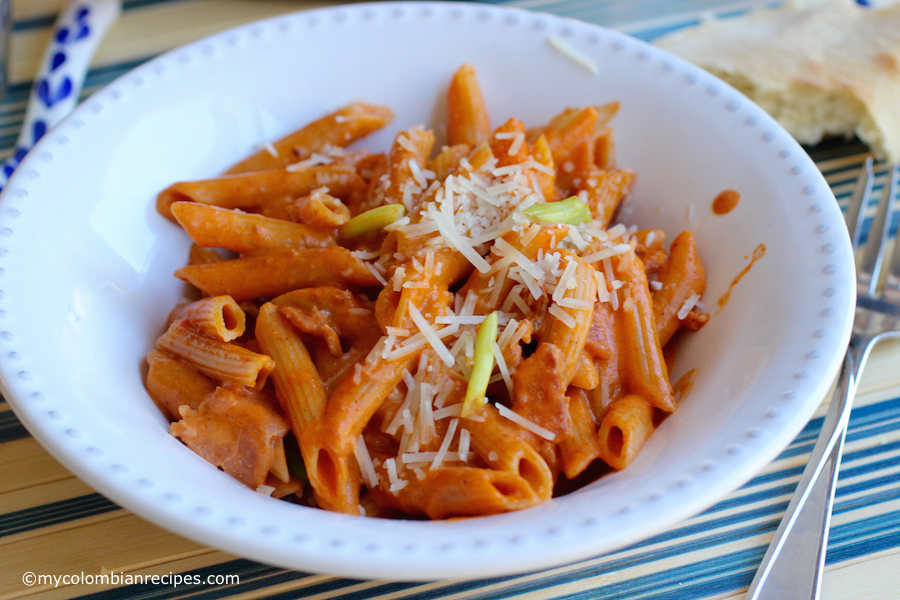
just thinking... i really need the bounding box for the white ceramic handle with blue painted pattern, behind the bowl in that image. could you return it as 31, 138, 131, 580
0, 0, 122, 187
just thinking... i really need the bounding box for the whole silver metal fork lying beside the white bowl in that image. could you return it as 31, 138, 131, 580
745, 158, 900, 600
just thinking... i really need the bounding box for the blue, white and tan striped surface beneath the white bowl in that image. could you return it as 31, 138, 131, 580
0, 0, 900, 600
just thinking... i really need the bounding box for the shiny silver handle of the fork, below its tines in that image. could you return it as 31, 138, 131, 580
745, 350, 858, 600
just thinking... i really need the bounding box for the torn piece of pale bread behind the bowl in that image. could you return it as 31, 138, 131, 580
656, 0, 900, 162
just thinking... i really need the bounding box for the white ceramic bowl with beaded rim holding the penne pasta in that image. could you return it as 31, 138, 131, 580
0, 2, 854, 580
